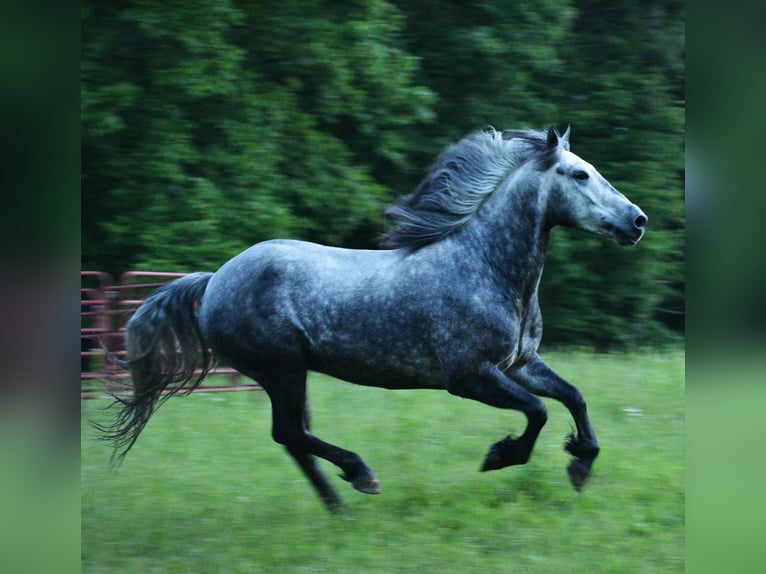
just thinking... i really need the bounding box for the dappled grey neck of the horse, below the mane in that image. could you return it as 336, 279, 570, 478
471, 174, 550, 296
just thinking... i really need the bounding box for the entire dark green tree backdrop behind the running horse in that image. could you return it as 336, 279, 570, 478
81, 0, 684, 347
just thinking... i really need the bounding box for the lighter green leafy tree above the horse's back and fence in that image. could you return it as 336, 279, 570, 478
82, 1, 432, 271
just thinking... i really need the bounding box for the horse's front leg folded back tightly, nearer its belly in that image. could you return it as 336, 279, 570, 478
447, 365, 548, 471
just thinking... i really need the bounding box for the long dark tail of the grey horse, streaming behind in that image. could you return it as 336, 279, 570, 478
96, 273, 213, 462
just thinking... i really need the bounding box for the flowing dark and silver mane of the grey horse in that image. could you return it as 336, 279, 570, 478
381, 127, 559, 250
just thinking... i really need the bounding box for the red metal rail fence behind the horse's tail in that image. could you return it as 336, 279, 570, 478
80, 271, 261, 399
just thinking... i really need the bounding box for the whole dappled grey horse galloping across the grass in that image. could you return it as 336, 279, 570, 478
101, 127, 647, 511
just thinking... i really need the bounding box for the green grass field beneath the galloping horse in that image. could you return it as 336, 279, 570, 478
81, 352, 684, 574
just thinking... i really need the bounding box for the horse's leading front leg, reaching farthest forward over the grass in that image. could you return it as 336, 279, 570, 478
508, 355, 600, 492
